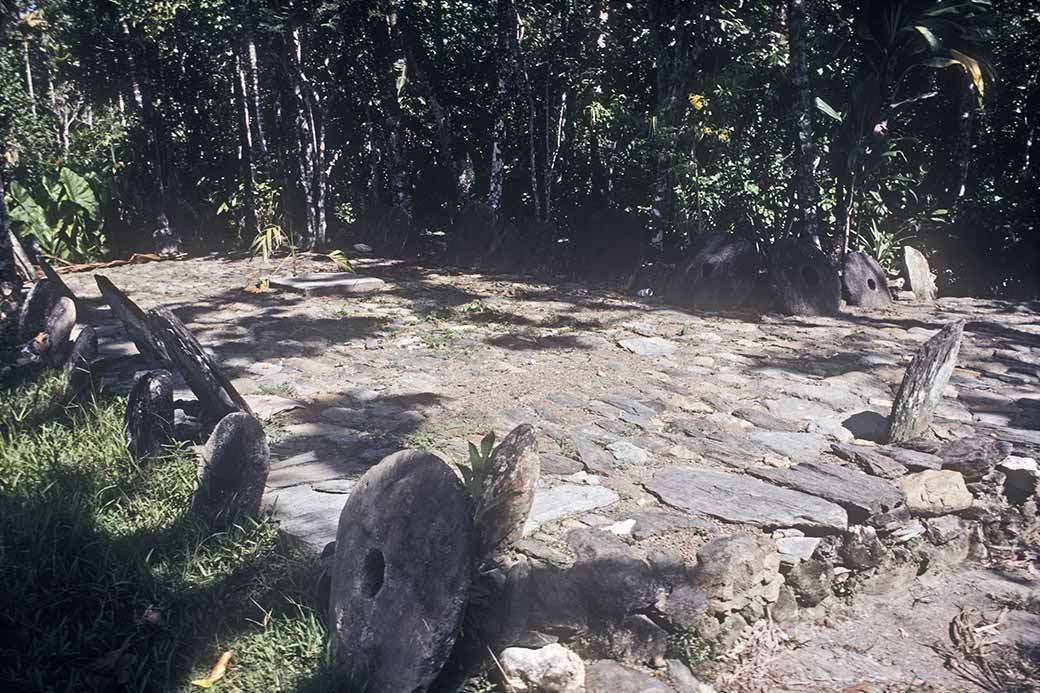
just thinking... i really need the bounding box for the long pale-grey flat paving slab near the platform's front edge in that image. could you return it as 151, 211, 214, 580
646, 465, 849, 532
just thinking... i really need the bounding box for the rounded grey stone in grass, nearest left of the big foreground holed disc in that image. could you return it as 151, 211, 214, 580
191, 411, 270, 523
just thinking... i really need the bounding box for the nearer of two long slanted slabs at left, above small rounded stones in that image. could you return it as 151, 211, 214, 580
148, 307, 253, 420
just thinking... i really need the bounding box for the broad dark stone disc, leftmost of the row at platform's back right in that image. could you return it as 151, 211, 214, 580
669, 233, 762, 310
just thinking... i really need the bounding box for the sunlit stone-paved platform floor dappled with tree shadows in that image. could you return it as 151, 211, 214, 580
68, 253, 1040, 690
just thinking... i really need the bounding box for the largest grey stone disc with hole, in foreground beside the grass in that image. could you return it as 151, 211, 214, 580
331, 451, 476, 693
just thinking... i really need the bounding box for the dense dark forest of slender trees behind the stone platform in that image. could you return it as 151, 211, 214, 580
0, 0, 1040, 298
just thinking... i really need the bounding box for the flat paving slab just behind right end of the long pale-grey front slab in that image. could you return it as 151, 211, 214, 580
748, 462, 903, 522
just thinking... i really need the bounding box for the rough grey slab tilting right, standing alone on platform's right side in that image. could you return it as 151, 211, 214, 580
888, 320, 964, 443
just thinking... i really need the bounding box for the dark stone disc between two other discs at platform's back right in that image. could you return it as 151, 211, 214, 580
770, 238, 841, 315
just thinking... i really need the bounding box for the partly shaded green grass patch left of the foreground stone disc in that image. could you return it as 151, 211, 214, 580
0, 378, 334, 691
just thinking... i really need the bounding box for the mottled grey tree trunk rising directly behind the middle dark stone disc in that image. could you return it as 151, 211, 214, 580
787, 0, 819, 248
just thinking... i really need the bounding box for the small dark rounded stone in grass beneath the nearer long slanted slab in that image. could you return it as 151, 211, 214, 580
124, 370, 174, 459
